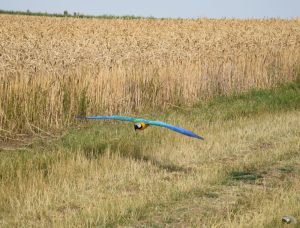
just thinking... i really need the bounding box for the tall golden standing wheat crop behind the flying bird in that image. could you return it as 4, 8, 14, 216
0, 15, 300, 138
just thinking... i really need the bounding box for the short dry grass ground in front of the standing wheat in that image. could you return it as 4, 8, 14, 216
0, 84, 300, 227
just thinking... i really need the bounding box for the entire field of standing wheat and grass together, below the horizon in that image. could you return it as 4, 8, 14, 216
0, 14, 300, 227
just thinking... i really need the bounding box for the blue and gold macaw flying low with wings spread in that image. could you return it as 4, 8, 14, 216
77, 116, 204, 140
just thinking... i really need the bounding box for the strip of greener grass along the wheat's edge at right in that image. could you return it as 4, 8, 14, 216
192, 82, 300, 121
